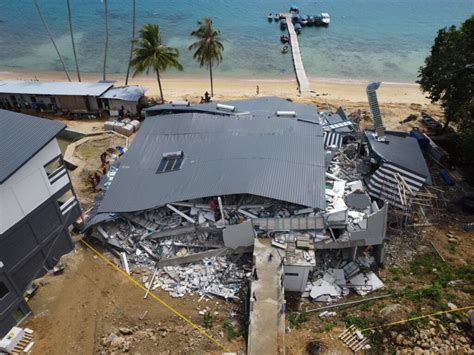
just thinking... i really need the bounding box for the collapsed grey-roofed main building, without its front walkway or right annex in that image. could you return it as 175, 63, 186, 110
83, 92, 432, 296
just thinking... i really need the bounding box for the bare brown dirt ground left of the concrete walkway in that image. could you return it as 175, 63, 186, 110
23, 244, 244, 355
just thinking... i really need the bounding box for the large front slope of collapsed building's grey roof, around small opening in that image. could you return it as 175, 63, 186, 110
99, 113, 325, 212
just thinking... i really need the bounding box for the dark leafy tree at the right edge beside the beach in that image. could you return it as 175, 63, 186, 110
417, 16, 474, 129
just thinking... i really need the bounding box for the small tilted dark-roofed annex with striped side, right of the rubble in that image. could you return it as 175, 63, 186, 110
362, 130, 431, 207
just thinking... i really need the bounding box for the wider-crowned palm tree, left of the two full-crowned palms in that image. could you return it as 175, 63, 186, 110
130, 23, 183, 102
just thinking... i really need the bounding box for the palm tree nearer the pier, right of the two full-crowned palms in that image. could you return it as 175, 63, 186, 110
189, 17, 224, 96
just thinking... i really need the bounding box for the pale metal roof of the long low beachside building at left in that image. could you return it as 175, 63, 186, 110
0, 80, 114, 96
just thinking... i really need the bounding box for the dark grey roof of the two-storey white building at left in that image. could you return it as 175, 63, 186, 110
0, 110, 66, 184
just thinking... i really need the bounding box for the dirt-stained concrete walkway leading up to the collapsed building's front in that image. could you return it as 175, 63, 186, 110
248, 238, 285, 355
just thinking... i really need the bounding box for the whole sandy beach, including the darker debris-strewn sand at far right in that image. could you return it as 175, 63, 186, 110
0, 71, 442, 130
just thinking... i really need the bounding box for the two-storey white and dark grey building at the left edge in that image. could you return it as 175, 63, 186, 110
0, 110, 81, 337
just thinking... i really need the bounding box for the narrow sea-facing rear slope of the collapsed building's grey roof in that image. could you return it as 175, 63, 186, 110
146, 96, 319, 123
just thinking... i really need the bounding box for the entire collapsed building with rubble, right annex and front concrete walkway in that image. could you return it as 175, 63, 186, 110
82, 92, 430, 353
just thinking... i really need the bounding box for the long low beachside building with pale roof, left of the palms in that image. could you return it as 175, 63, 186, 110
0, 80, 145, 116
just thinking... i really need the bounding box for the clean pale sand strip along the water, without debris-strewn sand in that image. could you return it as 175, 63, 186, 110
0, 71, 430, 105
